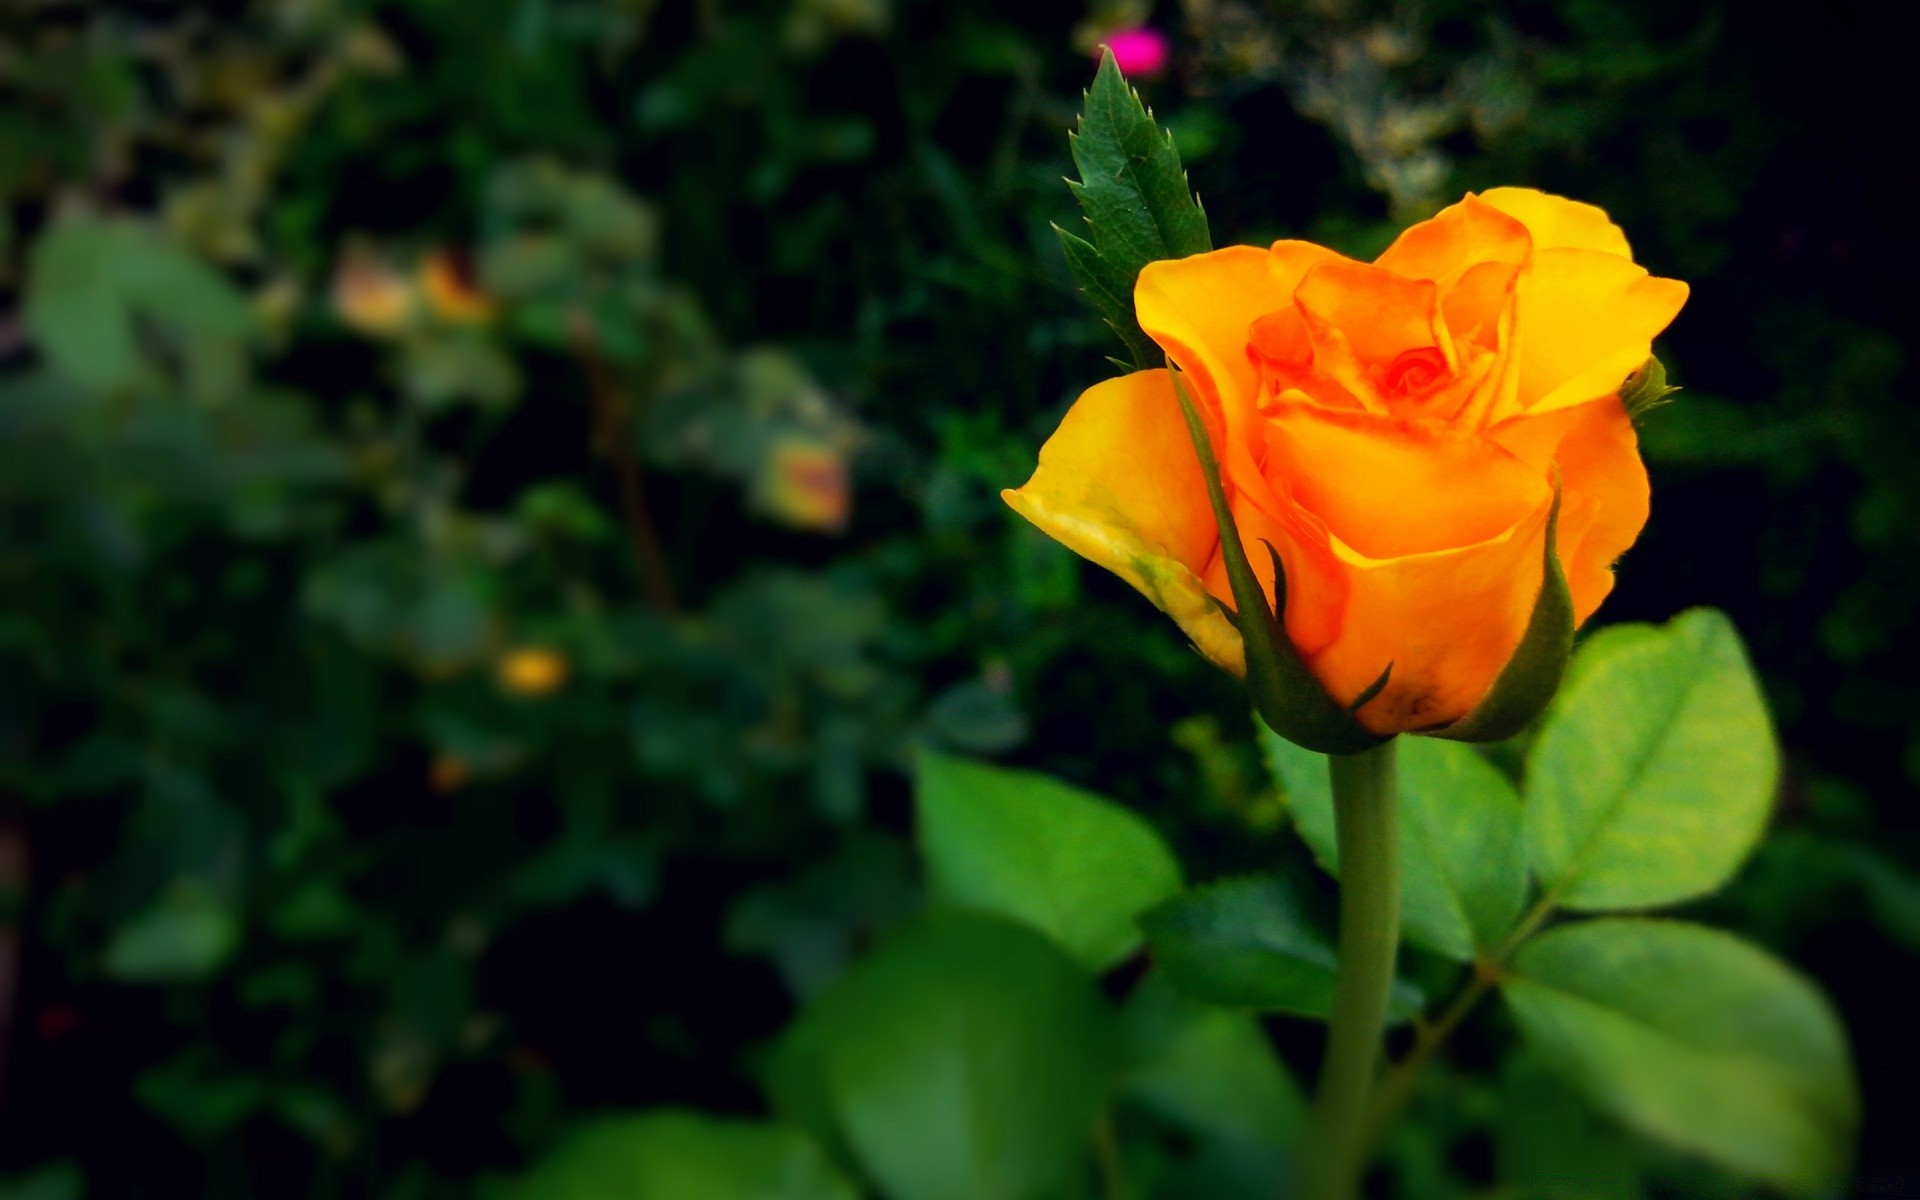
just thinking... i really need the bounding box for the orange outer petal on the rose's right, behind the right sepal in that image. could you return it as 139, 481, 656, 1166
1488, 396, 1647, 624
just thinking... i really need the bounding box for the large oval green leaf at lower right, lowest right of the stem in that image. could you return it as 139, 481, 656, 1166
1501, 918, 1859, 1188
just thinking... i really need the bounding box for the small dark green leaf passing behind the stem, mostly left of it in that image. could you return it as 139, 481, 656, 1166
1140, 876, 1421, 1020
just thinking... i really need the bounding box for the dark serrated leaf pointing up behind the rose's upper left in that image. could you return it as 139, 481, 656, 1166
1054, 52, 1213, 367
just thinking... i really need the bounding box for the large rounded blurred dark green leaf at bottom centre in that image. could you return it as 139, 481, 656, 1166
808, 912, 1114, 1200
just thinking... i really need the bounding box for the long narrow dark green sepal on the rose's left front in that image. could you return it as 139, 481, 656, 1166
1167, 370, 1394, 755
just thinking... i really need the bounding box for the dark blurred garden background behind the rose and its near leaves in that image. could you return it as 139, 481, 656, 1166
0, 0, 1920, 1200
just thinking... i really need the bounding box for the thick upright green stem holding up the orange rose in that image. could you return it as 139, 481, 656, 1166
1309, 741, 1400, 1200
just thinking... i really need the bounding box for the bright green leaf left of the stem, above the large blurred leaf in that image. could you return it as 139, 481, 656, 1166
914, 753, 1181, 972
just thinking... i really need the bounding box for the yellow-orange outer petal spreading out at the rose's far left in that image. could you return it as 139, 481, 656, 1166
1000, 371, 1246, 674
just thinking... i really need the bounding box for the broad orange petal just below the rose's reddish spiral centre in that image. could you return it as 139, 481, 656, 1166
1267, 397, 1553, 559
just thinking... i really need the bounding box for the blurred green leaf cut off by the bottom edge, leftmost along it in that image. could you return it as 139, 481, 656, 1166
505, 1110, 858, 1200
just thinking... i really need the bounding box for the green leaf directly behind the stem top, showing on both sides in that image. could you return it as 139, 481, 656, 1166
1258, 722, 1526, 962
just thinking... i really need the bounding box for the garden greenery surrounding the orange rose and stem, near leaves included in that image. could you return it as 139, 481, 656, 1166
0, 0, 1920, 1200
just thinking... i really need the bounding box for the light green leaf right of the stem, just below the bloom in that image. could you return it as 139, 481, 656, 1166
1526, 609, 1780, 910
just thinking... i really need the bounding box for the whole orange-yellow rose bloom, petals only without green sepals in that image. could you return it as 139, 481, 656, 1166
1002, 188, 1688, 733
